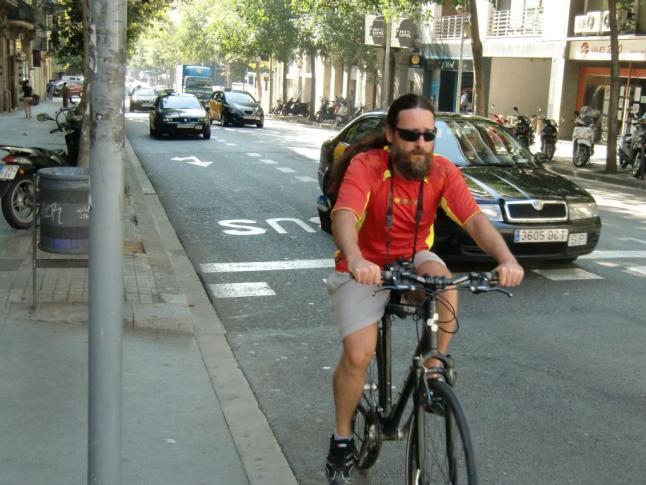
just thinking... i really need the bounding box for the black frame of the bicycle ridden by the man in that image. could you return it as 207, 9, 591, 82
377, 295, 448, 440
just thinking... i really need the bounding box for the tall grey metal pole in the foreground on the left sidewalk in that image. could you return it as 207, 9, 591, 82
88, 0, 126, 485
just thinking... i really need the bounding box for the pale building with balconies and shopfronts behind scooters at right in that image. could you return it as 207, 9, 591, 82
422, 0, 646, 137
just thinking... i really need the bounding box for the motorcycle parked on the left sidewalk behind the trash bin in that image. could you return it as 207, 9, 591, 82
0, 108, 81, 229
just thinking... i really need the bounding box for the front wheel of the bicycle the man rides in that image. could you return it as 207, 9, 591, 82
406, 379, 478, 485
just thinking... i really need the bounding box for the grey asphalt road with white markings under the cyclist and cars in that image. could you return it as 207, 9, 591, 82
127, 114, 646, 485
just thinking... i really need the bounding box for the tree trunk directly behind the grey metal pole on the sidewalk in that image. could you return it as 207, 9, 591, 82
78, 0, 96, 167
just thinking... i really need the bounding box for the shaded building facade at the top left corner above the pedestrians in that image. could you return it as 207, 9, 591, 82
0, 0, 55, 111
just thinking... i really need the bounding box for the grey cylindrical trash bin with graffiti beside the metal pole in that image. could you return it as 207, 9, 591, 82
38, 167, 90, 254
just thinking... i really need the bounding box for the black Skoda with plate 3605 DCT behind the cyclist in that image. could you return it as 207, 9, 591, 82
317, 111, 601, 262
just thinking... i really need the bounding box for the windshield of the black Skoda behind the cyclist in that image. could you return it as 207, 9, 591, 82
435, 118, 533, 166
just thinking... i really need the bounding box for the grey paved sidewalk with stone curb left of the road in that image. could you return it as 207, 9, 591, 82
0, 99, 296, 485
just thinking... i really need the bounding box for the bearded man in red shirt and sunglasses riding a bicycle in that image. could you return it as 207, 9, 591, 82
325, 94, 524, 484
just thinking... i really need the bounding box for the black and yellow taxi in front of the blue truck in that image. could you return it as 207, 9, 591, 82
206, 89, 265, 128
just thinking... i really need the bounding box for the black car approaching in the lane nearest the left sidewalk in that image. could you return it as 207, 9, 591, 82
149, 93, 211, 140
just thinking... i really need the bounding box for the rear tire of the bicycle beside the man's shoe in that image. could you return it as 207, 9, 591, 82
352, 322, 383, 470
